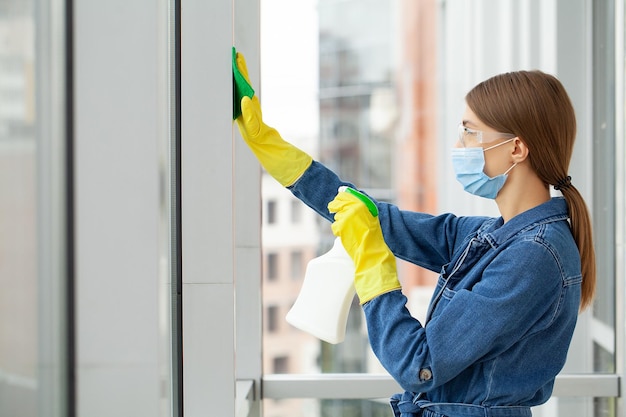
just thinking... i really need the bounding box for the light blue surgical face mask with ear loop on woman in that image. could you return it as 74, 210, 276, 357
452, 138, 517, 198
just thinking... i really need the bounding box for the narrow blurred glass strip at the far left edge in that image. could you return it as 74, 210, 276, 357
0, 2, 39, 416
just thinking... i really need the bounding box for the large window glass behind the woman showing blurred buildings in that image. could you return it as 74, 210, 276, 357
253, 0, 615, 415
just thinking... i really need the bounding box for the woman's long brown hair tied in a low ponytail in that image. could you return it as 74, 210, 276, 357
465, 71, 596, 310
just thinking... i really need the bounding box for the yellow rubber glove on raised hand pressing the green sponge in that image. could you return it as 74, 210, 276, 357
236, 52, 313, 187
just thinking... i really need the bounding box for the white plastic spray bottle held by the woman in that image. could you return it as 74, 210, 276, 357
286, 238, 355, 344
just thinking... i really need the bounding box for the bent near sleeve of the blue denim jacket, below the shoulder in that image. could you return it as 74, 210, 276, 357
363, 237, 577, 392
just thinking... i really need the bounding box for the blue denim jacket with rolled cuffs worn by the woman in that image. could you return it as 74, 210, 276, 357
289, 161, 582, 417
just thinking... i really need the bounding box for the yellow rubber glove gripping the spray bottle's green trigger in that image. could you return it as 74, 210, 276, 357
328, 187, 401, 304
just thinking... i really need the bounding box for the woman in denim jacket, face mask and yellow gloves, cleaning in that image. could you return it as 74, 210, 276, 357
236, 55, 595, 417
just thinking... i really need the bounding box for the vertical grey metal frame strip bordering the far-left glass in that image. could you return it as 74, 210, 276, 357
32, 0, 70, 417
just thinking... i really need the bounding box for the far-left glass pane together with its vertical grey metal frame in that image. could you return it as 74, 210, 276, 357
0, 0, 67, 417
